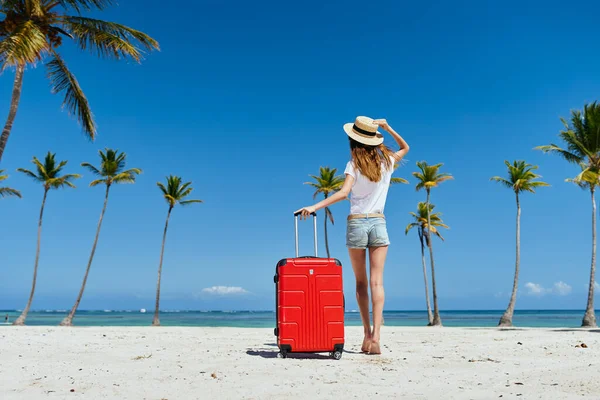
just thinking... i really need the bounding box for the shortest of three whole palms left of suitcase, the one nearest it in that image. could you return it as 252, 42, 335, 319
152, 175, 202, 326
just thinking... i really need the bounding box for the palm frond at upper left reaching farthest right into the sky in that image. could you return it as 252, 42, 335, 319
62, 16, 159, 63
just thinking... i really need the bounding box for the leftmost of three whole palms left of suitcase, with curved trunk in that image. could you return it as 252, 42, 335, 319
13, 152, 81, 325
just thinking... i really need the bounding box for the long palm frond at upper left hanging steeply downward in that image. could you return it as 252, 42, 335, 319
46, 51, 96, 140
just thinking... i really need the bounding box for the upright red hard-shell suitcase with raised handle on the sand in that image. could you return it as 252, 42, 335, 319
274, 214, 345, 360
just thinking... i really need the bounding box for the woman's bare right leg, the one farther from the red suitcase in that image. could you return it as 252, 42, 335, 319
369, 246, 388, 354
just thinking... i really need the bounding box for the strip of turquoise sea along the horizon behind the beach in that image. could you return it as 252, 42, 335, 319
0, 310, 596, 328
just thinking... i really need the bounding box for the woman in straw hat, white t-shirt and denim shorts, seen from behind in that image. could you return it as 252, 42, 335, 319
298, 117, 409, 354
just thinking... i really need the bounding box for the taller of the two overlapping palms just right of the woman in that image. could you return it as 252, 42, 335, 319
413, 161, 454, 326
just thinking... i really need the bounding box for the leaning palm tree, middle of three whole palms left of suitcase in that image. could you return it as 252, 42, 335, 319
60, 149, 142, 326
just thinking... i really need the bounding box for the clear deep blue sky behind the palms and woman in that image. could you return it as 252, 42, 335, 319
0, 0, 600, 309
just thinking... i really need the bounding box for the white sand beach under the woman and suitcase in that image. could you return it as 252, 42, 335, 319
0, 327, 600, 400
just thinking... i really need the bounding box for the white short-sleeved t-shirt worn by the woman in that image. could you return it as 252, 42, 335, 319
344, 157, 396, 214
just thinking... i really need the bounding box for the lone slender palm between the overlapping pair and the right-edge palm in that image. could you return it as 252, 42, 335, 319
490, 161, 550, 327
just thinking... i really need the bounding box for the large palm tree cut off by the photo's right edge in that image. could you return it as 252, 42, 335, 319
536, 102, 600, 327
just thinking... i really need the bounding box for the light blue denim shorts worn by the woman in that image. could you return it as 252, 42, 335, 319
346, 217, 390, 249
